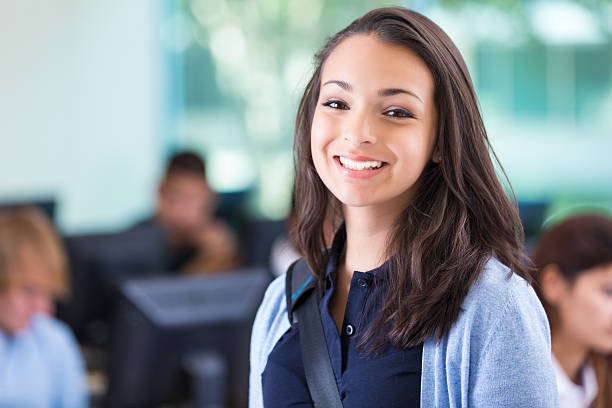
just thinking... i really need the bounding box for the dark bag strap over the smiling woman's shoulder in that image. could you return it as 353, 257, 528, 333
286, 259, 342, 408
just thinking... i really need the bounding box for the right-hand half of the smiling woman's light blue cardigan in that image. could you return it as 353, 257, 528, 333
423, 258, 556, 407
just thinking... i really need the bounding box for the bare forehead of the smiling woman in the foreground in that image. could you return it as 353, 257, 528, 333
321, 34, 433, 96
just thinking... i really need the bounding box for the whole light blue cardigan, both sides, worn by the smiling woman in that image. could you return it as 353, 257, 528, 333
249, 259, 559, 408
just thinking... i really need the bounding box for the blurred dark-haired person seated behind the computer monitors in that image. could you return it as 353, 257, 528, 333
136, 151, 240, 274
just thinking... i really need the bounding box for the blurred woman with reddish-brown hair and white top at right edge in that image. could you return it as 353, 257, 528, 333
533, 214, 612, 408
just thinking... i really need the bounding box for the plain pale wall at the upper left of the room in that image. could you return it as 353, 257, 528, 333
0, 0, 162, 232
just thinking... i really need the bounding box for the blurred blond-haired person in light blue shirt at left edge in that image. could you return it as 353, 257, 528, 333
0, 207, 87, 408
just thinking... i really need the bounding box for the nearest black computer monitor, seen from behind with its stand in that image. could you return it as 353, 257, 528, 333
106, 268, 269, 408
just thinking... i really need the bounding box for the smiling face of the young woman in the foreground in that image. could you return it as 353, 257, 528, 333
311, 35, 437, 211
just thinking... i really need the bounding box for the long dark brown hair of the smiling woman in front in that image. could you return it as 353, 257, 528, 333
294, 7, 529, 351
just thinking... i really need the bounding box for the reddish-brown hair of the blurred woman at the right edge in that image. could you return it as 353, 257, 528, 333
533, 214, 612, 408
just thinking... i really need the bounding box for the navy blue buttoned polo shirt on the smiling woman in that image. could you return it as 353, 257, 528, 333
262, 226, 423, 408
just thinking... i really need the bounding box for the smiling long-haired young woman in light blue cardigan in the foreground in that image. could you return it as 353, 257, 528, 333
250, 8, 558, 408
